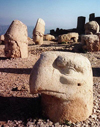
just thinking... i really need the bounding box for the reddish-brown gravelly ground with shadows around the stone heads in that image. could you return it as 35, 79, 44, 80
0, 42, 100, 127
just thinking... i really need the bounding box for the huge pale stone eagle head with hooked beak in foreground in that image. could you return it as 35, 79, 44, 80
29, 51, 93, 122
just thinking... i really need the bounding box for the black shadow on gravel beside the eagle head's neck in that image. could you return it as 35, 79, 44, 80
0, 96, 42, 122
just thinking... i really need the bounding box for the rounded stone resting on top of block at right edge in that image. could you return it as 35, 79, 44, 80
85, 21, 99, 34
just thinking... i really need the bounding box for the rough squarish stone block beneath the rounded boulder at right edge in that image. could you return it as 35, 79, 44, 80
81, 35, 100, 52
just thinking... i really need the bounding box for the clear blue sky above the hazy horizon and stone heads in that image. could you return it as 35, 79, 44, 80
0, 0, 100, 29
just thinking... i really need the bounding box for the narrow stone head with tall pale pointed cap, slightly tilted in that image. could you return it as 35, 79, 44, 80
33, 18, 45, 45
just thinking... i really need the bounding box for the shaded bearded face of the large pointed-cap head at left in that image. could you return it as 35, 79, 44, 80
4, 40, 21, 58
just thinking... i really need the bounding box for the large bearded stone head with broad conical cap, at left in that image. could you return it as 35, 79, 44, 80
4, 20, 28, 58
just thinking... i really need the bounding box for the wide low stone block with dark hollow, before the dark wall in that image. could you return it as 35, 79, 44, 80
58, 32, 79, 43
